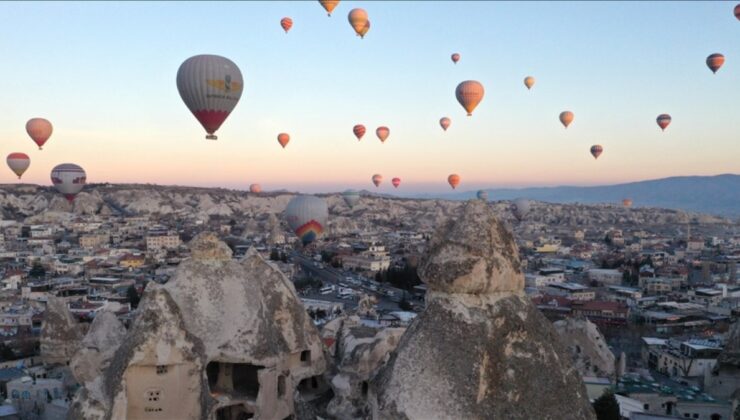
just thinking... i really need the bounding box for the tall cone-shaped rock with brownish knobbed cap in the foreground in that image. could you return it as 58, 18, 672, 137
369, 202, 594, 419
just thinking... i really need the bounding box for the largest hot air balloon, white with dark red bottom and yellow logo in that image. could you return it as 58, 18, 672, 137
177, 55, 244, 140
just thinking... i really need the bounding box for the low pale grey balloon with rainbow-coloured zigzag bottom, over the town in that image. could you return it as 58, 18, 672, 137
285, 195, 329, 246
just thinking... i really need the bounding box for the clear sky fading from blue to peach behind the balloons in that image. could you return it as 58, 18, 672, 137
0, 1, 740, 195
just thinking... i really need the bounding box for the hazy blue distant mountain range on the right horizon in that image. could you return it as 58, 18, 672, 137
417, 174, 740, 217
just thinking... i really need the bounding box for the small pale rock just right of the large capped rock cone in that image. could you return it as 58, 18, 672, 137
554, 318, 617, 379
